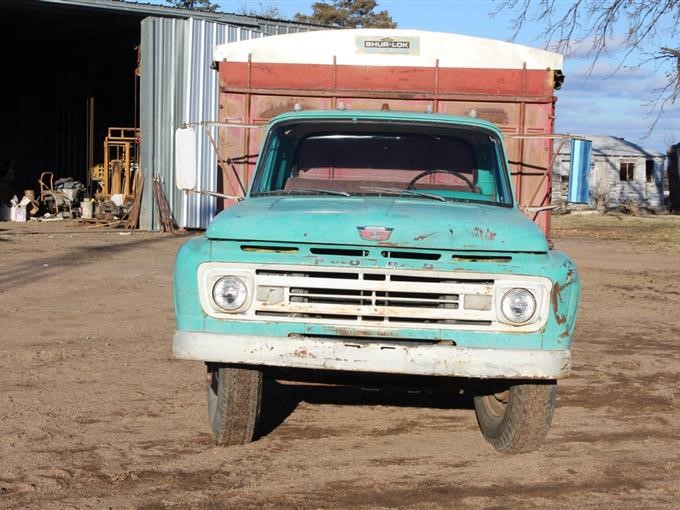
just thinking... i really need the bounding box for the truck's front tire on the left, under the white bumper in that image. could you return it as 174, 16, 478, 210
208, 363, 262, 445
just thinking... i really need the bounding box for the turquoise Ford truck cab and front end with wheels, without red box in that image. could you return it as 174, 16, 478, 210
173, 110, 580, 452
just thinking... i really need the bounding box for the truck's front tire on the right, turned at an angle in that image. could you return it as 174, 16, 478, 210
475, 381, 557, 453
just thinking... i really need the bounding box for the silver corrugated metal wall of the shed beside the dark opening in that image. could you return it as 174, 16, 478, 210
140, 17, 262, 230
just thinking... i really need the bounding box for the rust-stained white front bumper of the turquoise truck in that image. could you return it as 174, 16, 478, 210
173, 331, 571, 379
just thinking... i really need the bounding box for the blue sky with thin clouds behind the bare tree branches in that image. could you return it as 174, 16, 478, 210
212, 0, 680, 153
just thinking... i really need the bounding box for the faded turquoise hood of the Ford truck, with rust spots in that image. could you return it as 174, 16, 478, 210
206, 196, 548, 253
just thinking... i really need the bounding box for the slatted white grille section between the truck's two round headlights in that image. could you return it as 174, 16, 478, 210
249, 269, 494, 326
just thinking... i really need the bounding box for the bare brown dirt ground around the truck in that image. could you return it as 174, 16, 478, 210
0, 213, 680, 509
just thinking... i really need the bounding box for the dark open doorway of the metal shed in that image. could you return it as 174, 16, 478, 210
0, 0, 144, 203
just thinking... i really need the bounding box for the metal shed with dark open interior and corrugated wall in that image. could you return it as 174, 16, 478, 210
0, 0, 315, 229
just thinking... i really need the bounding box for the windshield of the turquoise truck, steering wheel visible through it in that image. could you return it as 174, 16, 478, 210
251, 120, 512, 205
